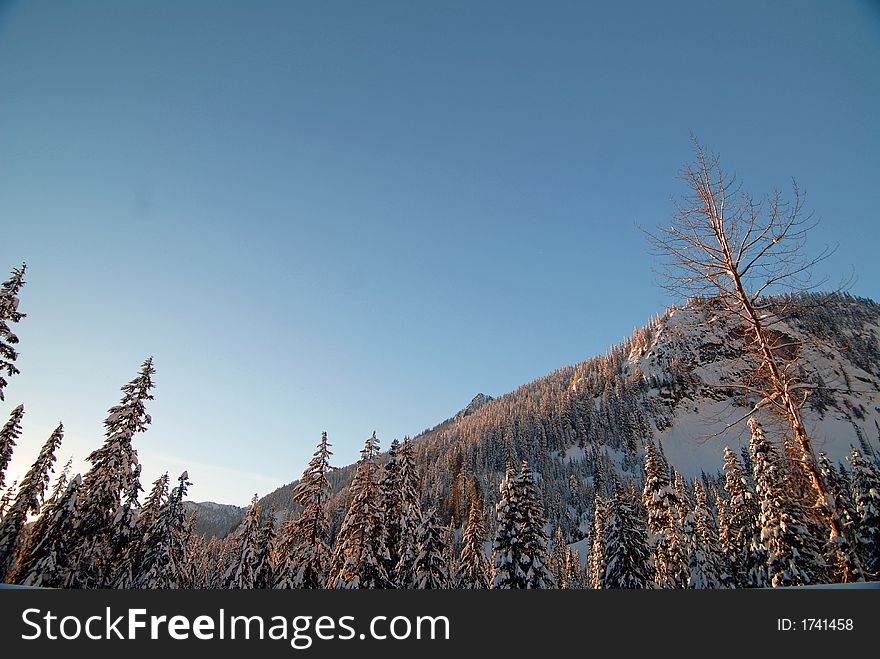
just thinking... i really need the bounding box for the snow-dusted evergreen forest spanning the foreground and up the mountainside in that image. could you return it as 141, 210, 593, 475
0, 267, 880, 589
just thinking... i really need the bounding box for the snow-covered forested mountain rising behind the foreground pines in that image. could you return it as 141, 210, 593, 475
192, 294, 880, 540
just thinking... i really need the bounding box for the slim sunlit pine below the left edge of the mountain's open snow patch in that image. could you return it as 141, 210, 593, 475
642, 442, 688, 588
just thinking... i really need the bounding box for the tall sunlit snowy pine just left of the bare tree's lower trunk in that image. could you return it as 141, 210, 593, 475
749, 418, 819, 588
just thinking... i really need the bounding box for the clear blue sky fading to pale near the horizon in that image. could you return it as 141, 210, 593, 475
0, 0, 880, 504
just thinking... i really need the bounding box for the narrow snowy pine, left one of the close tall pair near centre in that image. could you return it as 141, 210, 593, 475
491, 464, 526, 589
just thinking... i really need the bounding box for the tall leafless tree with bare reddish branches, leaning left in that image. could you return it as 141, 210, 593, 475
649, 141, 861, 581
